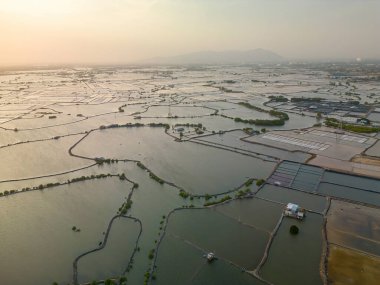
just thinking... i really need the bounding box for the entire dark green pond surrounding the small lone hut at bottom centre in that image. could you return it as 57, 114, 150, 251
155, 199, 282, 284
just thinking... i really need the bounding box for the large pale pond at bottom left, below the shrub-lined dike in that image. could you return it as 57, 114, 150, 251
0, 178, 132, 284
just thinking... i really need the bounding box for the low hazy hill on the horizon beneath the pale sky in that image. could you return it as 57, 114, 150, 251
143, 49, 283, 64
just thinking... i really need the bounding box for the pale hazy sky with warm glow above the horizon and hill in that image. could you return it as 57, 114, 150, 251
0, 0, 380, 65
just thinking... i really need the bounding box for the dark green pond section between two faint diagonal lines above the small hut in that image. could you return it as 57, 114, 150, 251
162, 206, 269, 269
